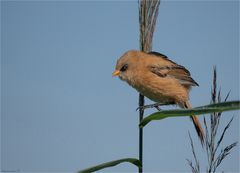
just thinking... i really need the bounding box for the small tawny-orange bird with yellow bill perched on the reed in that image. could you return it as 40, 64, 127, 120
112, 50, 204, 144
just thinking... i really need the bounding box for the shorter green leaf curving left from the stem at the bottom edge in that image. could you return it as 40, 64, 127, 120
78, 158, 142, 173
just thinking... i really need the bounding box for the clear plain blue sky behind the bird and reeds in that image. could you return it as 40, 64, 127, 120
1, 1, 239, 172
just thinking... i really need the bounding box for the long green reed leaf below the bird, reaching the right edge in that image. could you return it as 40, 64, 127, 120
139, 101, 240, 127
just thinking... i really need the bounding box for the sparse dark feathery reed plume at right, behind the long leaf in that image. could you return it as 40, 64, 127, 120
188, 67, 237, 173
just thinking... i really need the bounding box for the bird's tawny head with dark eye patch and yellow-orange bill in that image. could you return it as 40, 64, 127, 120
112, 50, 139, 82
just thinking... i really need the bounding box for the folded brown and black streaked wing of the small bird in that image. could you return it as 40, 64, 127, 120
149, 52, 198, 86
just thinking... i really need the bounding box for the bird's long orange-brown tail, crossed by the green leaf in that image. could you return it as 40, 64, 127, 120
184, 102, 204, 145
